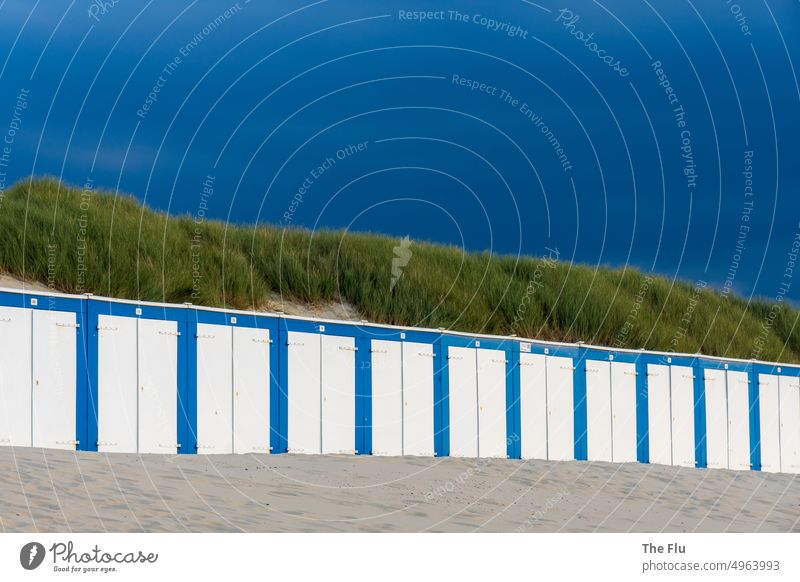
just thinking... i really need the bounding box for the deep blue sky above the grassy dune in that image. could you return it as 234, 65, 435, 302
0, 0, 800, 300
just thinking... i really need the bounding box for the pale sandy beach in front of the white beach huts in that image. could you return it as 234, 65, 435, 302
0, 448, 800, 532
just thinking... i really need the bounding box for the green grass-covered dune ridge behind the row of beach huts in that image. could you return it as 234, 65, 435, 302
0, 179, 800, 362
